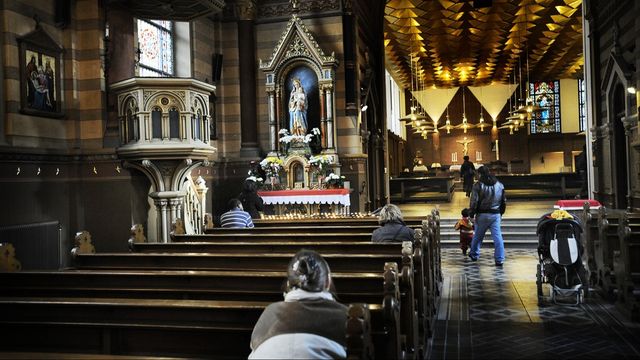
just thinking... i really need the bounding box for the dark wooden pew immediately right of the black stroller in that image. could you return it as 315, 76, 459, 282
594, 206, 622, 299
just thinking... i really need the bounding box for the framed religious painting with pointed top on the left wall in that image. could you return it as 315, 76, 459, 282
17, 24, 64, 117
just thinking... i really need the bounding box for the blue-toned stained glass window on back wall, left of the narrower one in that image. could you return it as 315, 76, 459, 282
529, 80, 561, 134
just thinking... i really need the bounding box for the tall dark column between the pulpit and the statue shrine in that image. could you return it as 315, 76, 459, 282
236, 0, 259, 157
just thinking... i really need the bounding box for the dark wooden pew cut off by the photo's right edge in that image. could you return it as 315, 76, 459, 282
614, 212, 640, 321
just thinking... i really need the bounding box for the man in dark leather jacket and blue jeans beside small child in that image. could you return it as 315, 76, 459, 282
469, 166, 507, 266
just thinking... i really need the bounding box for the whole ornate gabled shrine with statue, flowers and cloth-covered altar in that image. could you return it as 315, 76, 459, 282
259, 13, 350, 214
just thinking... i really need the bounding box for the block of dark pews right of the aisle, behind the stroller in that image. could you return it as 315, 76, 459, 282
582, 203, 640, 321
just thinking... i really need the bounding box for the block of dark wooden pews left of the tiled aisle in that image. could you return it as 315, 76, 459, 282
0, 210, 442, 359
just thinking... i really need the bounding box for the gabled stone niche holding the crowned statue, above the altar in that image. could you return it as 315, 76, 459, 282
260, 13, 338, 158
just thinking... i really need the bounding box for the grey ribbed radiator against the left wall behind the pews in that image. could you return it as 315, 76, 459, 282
0, 221, 63, 270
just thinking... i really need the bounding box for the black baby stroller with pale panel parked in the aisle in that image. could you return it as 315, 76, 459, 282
536, 214, 589, 305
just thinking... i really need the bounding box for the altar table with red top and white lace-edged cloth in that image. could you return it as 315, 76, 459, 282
258, 189, 351, 215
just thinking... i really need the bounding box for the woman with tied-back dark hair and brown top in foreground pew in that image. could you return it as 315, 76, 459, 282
249, 250, 347, 359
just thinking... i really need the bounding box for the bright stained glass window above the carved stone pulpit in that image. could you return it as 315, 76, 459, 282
138, 19, 174, 77
